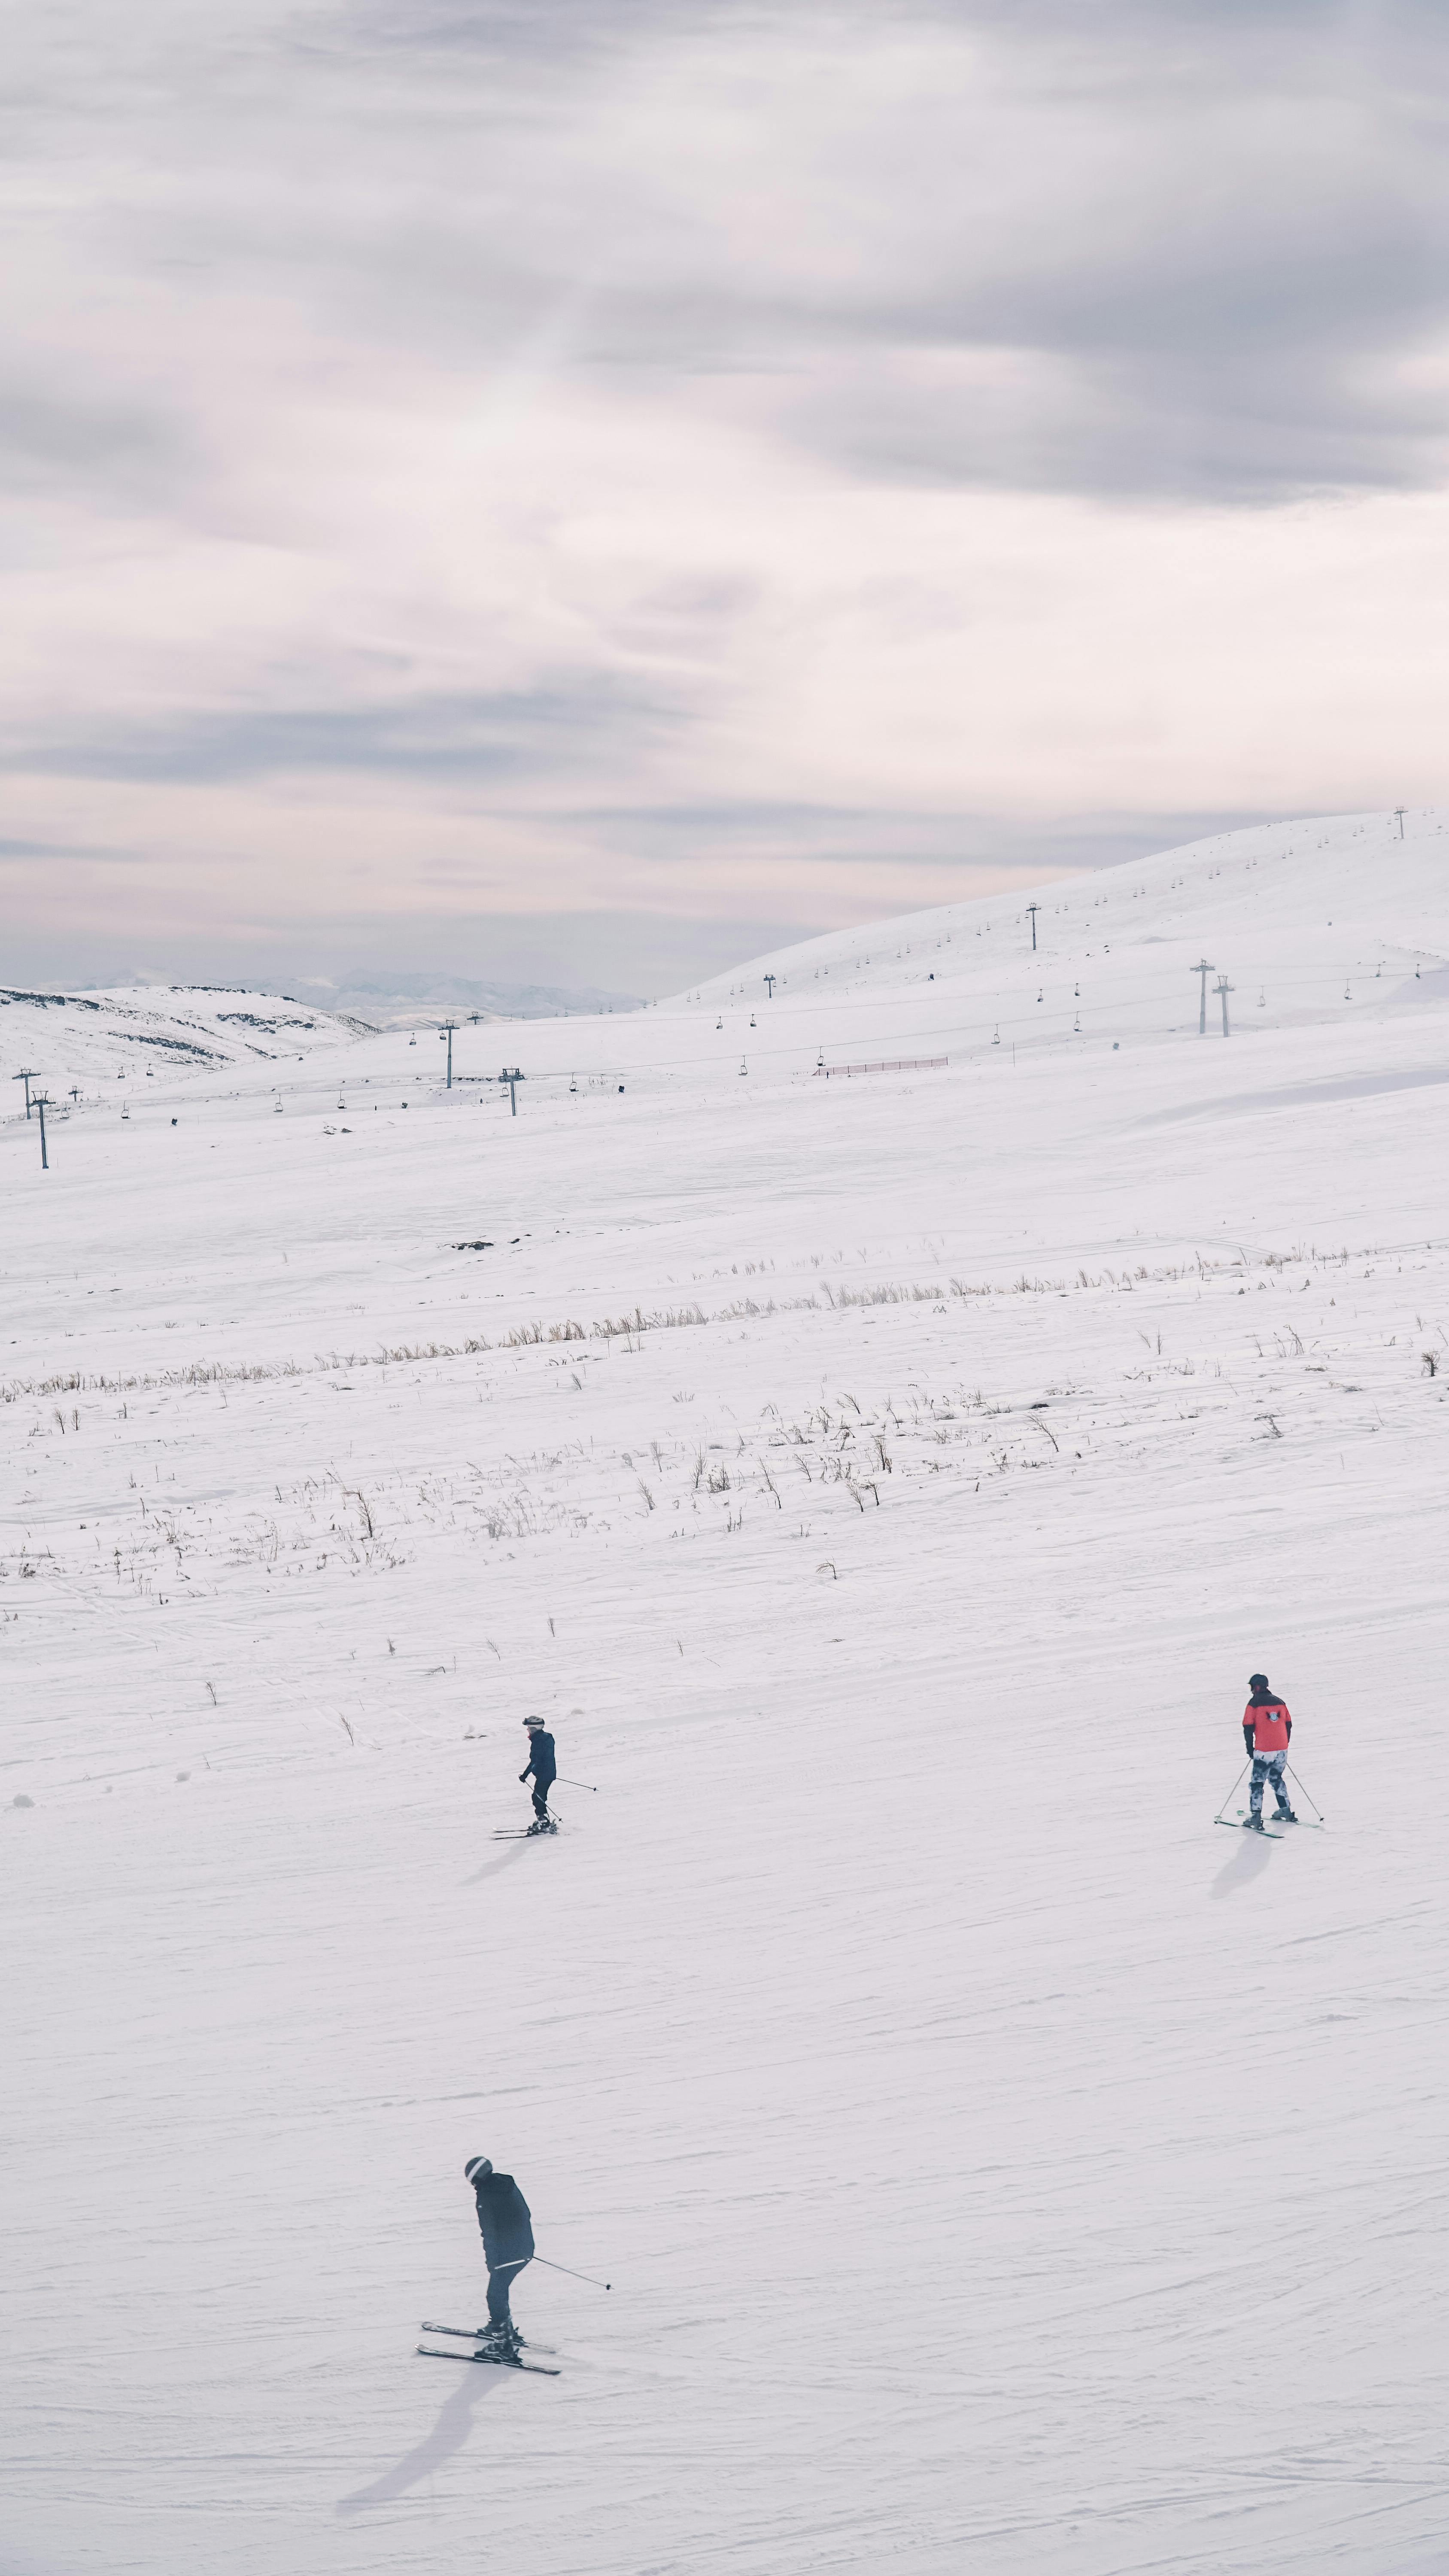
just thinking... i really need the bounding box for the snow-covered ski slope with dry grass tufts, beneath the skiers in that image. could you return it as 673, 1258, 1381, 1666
0, 811, 1449, 2576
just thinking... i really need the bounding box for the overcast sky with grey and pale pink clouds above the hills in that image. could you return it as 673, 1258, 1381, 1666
0, 0, 1449, 992
